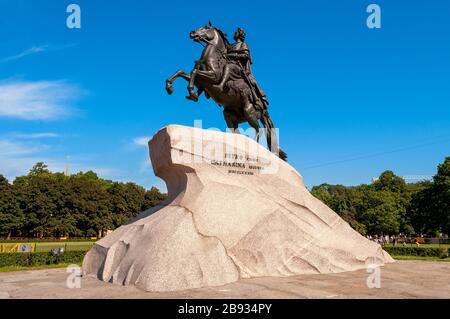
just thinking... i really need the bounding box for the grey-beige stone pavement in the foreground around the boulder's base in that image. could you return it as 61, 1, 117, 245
0, 261, 450, 299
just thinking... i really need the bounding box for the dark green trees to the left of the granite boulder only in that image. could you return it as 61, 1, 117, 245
0, 163, 166, 238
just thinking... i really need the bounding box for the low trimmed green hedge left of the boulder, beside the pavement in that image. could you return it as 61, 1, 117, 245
0, 251, 86, 267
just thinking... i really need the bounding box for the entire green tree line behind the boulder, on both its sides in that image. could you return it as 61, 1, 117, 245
0, 157, 450, 238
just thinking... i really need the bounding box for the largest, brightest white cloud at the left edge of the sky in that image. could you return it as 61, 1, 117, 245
0, 81, 85, 120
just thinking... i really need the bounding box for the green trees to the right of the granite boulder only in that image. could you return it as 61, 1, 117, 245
312, 157, 450, 237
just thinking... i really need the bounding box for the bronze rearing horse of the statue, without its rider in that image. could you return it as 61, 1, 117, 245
166, 24, 287, 160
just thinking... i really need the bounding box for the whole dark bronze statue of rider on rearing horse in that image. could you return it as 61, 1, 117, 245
166, 23, 287, 160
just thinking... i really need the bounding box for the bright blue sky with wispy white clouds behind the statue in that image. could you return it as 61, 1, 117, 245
0, 0, 450, 188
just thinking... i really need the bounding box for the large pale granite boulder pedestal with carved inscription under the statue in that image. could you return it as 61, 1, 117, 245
83, 125, 393, 291
